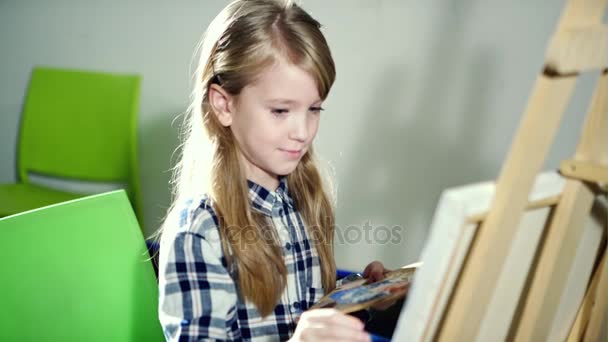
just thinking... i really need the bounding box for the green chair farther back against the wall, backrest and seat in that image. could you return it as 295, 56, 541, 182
0, 67, 143, 225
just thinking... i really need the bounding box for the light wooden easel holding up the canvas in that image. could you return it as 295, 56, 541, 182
435, 0, 608, 341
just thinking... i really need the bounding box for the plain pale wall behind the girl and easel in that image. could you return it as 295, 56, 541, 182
0, 0, 596, 269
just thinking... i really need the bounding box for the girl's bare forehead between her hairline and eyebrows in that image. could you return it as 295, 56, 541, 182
243, 61, 320, 104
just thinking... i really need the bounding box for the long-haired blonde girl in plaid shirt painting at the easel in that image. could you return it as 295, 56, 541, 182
159, 0, 385, 341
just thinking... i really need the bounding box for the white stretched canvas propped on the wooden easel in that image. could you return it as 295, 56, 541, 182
393, 172, 565, 341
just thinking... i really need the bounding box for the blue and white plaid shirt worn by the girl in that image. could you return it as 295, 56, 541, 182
159, 177, 324, 341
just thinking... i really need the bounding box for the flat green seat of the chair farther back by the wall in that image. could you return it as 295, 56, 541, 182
0, 183, 85, 217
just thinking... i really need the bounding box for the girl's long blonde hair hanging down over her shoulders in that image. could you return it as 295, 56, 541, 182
161, 0, 336, 316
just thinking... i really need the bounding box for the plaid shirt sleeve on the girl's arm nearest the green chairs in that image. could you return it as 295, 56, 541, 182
159, 226, 241, 341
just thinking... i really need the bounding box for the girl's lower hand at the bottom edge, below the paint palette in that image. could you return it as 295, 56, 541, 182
290, 309, 371, 342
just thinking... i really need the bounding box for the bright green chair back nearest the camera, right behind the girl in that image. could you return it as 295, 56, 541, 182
0, 190, 164, 342
